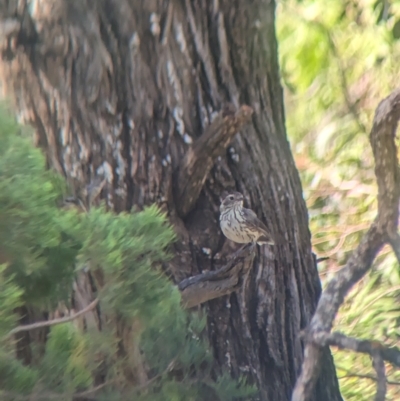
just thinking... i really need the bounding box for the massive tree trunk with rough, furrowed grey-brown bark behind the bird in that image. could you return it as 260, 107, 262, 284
0, 0, 341, 401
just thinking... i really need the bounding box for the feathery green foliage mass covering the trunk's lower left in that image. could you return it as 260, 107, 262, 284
0, 109, 255, 401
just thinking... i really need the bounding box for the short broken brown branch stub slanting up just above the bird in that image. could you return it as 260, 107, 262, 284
174, 104, 253, 216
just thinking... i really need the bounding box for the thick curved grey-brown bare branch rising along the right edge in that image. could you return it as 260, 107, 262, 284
292, 89, 400, 401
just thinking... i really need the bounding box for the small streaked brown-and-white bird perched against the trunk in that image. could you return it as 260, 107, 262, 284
219, 192, 274, 245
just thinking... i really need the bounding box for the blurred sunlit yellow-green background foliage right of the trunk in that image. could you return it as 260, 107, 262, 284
278, 0, 400, 401
